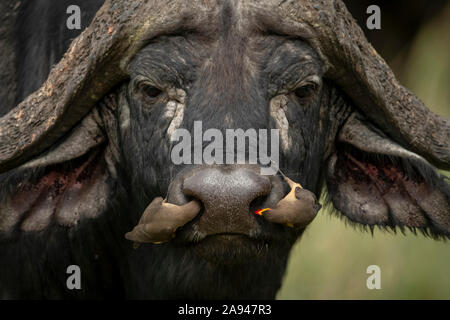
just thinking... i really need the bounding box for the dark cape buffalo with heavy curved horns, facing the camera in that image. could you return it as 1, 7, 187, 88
0, 0, 450, 299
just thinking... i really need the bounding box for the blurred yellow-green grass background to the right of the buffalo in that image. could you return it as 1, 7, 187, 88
277, 5, 450, 299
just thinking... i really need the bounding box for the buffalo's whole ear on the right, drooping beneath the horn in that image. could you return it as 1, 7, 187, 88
326, 113, 450, 238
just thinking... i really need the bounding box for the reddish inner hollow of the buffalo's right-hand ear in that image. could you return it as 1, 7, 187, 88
336, 152, 433, 227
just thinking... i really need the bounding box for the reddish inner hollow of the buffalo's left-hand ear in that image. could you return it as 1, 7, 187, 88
10, 152, 106, 231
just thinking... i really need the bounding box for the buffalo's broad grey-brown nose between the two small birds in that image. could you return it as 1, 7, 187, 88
165, 165, 284, 235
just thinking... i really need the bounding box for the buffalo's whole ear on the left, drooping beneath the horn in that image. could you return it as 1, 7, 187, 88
0, 104, 115, 233
